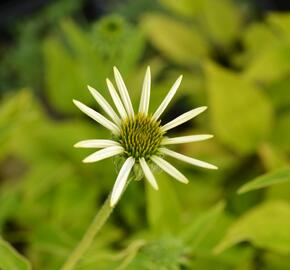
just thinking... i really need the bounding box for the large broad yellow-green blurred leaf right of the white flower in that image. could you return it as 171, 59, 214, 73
206, 63, 272, 153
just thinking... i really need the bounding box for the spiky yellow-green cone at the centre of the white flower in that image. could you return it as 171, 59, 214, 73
119, 113, 164, 160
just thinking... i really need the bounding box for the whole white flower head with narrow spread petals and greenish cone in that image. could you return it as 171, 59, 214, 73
73, 67, 217, 207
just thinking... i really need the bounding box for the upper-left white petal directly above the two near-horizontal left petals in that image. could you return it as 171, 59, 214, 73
73, 100, 119, 134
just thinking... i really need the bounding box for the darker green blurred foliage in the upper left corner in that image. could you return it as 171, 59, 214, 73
0, 0, 82, 94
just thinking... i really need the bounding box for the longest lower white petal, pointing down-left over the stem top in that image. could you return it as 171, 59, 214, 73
110, 157, 135, 207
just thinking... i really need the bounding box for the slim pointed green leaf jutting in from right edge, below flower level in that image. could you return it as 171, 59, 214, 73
238, 168, 290, 193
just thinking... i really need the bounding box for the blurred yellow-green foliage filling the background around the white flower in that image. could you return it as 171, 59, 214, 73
0, 0, 290, 270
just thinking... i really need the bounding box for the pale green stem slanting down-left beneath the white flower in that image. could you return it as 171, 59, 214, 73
61, 196, 114, 270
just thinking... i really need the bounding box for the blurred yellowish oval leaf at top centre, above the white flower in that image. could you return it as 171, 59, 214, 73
141, 13, 208, 65
